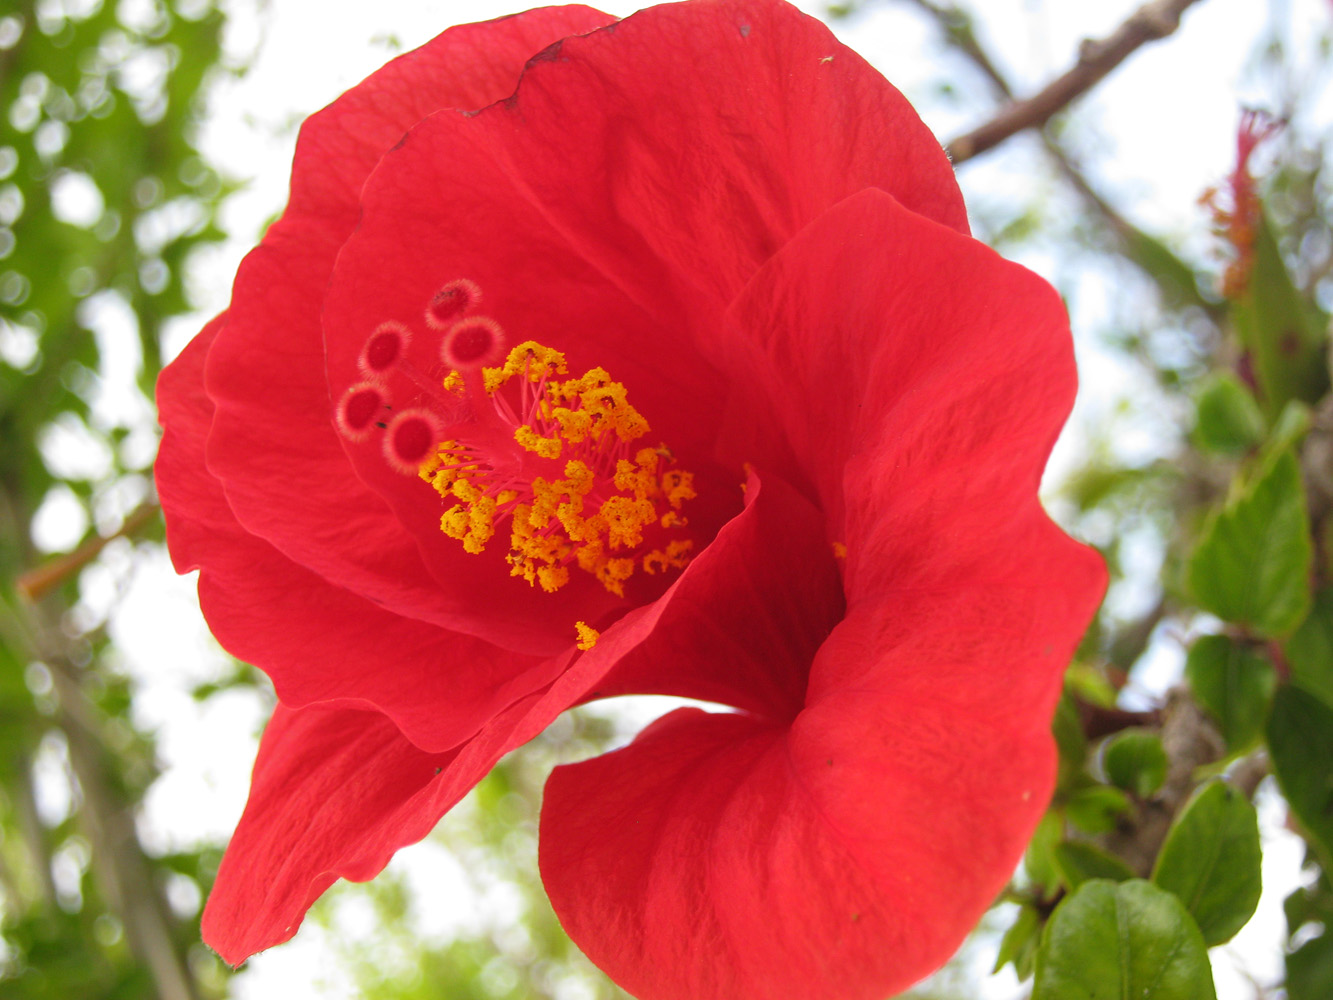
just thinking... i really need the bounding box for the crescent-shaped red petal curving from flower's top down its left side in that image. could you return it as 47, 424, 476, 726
194, 7, 612, 652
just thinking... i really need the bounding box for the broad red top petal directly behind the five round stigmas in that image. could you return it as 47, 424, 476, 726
325, 0, 966, 509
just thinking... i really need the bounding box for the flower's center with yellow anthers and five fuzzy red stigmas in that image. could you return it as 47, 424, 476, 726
335, 281, 694, 596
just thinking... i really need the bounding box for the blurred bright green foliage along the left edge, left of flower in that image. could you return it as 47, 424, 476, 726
0, 0, 224, 1000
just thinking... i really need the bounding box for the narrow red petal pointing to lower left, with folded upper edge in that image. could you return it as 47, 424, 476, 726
203, 584, 677, 964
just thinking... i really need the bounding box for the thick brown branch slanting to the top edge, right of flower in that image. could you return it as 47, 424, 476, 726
946, 0, 1198, 164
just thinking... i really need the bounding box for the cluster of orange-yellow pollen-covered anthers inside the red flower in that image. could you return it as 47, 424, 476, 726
420, 340, 696, 600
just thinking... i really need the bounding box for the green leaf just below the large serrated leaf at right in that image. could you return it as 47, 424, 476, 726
1185, 636, 1277, 753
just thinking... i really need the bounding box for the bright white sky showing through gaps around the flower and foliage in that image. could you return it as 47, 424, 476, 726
59, 0, 1333, 1000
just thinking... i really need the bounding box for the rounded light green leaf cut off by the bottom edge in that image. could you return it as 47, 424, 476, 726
1032, 879, 1217, 1000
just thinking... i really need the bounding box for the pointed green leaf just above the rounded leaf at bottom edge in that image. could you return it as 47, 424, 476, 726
1153, 781, 1262, 947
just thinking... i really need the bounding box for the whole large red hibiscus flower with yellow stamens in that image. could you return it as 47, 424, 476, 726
157, 0, 1104, 1000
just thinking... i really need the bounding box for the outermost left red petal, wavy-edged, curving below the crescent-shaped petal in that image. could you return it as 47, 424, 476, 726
156, 316, 572, 751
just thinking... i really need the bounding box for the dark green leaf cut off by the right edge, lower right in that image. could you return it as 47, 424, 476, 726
1268, 684, 1333, 871
